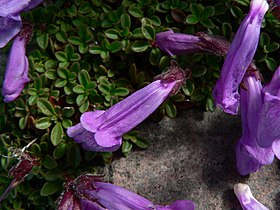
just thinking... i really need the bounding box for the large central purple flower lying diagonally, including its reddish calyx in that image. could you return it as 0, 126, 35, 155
67, 63, 185, 151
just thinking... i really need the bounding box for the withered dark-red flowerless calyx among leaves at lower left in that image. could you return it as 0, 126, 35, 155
0, 153, 38, 202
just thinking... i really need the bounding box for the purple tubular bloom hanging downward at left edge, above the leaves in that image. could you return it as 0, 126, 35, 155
2, 36, 29, 102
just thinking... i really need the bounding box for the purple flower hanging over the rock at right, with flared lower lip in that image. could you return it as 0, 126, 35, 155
235, 75, 274, 175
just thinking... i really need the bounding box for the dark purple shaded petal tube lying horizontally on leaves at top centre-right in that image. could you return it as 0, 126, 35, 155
155, 30, 202, 56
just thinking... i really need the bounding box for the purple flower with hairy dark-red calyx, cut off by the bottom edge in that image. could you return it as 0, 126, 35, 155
57, 174, 194, 210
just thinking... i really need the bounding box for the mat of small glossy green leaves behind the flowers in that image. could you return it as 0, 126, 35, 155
0, 0, 280, 209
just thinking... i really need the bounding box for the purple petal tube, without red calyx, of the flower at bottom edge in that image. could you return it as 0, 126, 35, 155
87, 182, 154, 210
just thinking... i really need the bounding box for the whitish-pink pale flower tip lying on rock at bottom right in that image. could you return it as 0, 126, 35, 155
234, 183, 269, 210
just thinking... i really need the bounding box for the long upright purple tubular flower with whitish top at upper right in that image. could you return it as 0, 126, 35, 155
213, 0, 268, 114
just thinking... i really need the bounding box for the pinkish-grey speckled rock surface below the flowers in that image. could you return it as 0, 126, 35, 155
111, 109, 280, 210
